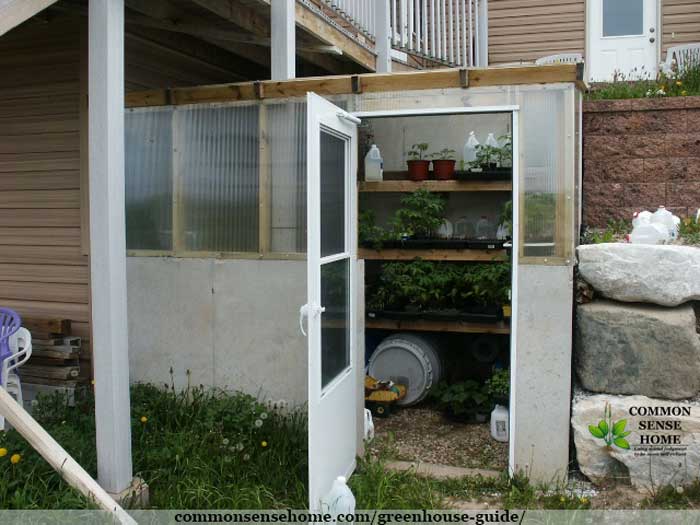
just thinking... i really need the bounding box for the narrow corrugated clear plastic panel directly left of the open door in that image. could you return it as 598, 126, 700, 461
263, 102, 306, 253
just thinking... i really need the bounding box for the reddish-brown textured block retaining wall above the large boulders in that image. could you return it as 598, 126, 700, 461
583, 97, 700, 226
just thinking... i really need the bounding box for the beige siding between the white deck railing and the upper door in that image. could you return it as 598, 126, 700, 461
489, 0, 586, 64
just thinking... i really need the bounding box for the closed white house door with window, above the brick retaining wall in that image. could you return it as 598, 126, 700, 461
587, 0, 660, 82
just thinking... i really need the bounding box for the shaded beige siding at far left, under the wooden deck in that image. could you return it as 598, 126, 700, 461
0, 17, 90, 348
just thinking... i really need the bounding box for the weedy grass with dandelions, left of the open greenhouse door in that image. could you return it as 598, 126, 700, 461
0, 376, 307, 509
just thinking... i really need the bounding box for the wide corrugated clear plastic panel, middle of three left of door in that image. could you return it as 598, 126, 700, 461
175, 105, 260, 252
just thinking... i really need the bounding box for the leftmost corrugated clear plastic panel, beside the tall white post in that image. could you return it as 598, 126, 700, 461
124, 108, 173, 251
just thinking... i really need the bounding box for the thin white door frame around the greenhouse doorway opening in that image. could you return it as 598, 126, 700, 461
352, 106, 520, 475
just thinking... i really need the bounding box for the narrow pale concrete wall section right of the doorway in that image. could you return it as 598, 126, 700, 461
511, 265, 573, 482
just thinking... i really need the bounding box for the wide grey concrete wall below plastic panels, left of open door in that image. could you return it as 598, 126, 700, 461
127, 257, 307, 404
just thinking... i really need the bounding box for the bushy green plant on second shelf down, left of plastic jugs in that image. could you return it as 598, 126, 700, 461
392, 189, 445, 238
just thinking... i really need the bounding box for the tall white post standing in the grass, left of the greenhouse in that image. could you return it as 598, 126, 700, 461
88, 0, 132, 494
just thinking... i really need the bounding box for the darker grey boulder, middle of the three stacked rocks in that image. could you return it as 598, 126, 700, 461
575, 301, 700, 399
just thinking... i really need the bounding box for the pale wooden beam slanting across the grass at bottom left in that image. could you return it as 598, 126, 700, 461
0, 387, 136, 525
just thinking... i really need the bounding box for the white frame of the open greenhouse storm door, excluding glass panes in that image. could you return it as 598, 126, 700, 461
300, 93, 359, 511
